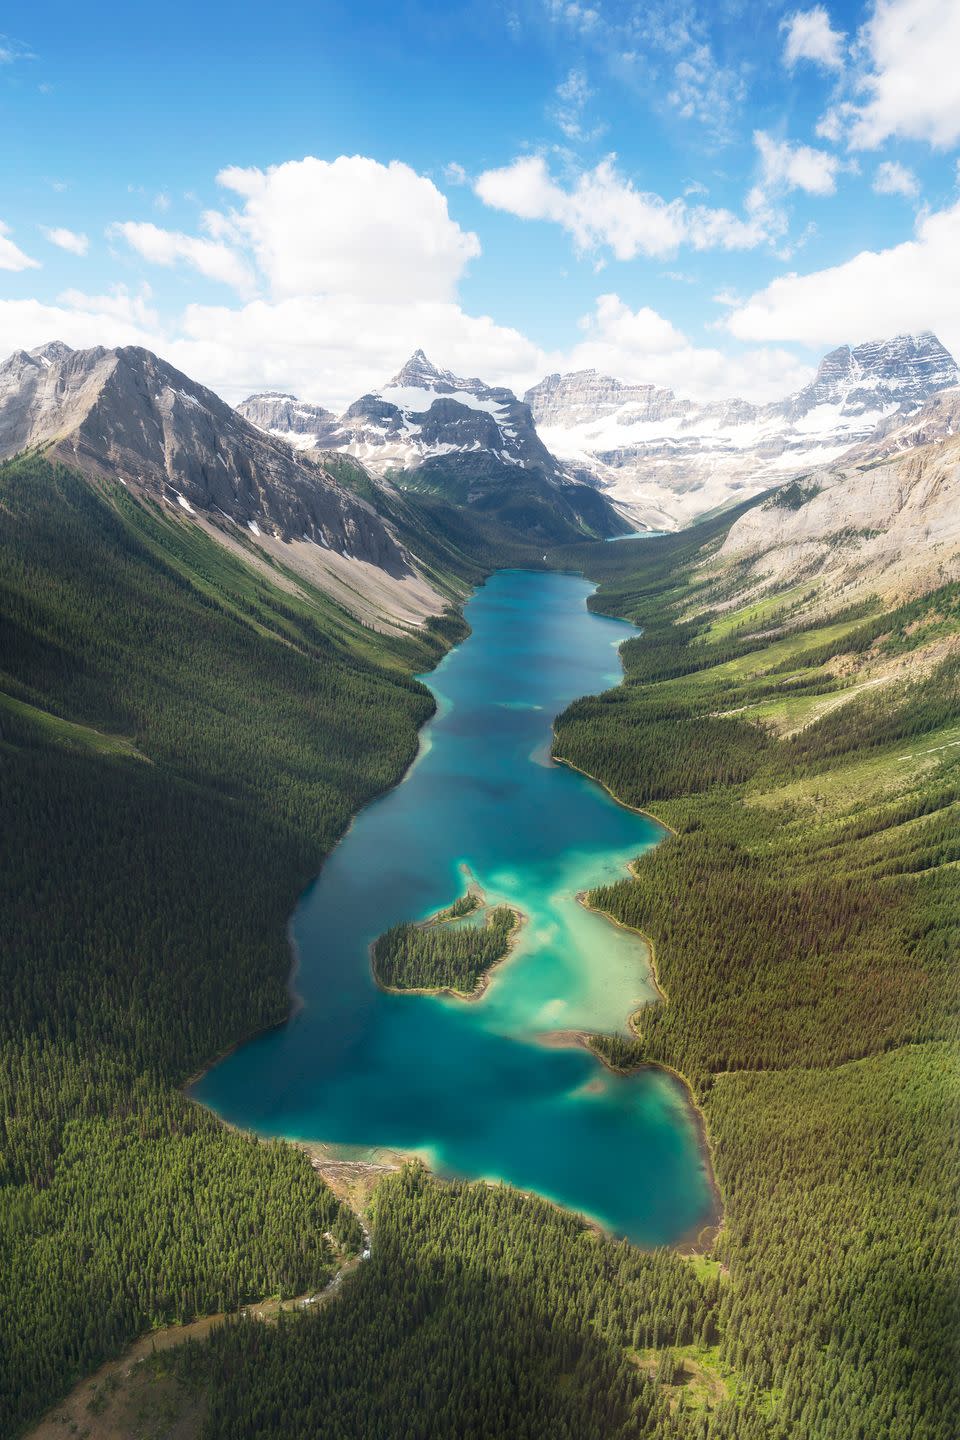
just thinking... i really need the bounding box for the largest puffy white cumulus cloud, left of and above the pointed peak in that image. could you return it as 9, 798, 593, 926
217, 156, 481, 301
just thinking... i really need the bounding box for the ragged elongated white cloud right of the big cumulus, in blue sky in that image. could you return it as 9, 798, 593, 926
475, 156, 766, 261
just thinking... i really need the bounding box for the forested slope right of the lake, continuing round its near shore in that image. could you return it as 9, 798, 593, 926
146, 512, 960, 1440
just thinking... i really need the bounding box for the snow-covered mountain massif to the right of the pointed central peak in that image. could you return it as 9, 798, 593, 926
524, 331, 960, 528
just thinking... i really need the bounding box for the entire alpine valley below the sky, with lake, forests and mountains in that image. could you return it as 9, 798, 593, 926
0, 321, 960, 1440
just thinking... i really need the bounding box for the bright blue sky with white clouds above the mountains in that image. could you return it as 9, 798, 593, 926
0, 0, 960, 409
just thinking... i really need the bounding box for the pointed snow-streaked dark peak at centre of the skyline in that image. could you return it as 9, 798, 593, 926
237, 350, 560, 474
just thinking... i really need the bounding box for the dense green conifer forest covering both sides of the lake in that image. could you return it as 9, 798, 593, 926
0, 459, 960, 1440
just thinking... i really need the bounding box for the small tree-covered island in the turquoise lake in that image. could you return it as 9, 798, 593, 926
370, 886, 524, 999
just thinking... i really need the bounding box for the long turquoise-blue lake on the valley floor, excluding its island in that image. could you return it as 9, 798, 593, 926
193, 570, 711, 1244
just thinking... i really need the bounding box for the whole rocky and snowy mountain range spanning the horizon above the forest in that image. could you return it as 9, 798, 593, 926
0, 333, 960, 629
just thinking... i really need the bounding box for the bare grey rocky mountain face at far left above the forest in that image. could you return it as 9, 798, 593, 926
0, 341, 409, 575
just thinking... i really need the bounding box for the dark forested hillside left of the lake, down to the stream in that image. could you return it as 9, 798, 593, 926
0, 459, 461, 1434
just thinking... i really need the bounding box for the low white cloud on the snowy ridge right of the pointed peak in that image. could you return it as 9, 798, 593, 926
553, 295, 812, 403
